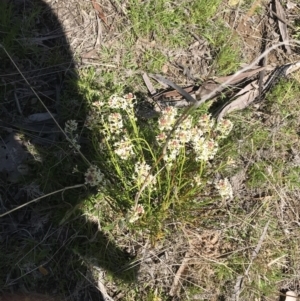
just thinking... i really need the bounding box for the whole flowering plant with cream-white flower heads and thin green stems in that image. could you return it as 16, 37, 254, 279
72, 93, 233, 231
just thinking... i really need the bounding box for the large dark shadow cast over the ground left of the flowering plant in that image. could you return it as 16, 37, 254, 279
0, 0, 136, 300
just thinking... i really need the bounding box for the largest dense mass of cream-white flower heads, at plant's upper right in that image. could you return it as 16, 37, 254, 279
156, 111, 232, 164
